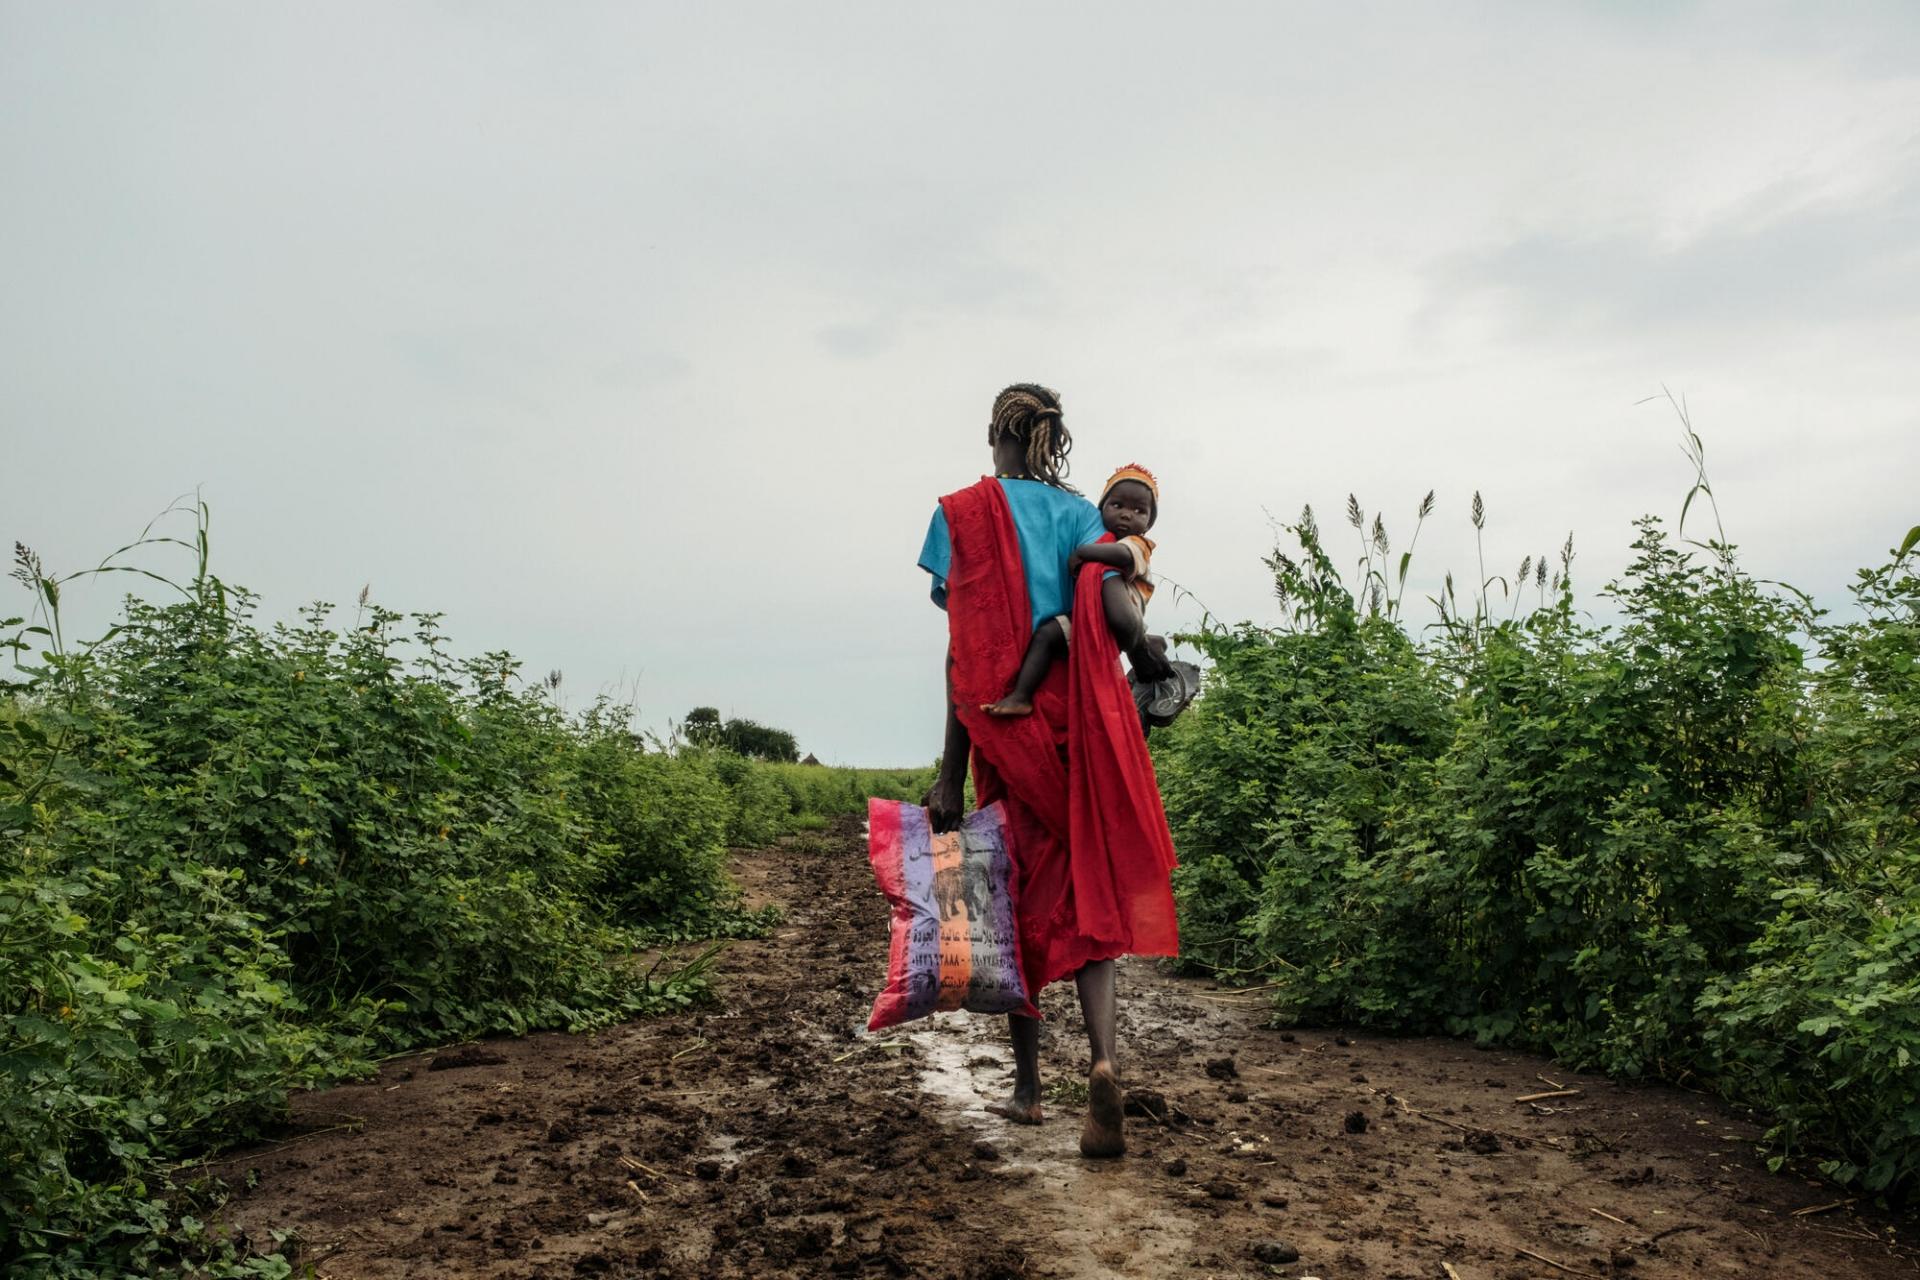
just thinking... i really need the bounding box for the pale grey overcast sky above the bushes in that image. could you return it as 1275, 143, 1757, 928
0, 0, 1920, 764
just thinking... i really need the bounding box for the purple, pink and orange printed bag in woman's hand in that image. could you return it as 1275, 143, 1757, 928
866, 800, 1039, 1031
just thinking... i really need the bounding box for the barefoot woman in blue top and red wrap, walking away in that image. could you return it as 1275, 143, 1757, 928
920, 382, 1179, 1157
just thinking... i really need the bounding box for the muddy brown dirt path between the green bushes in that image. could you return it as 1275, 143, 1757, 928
219, 823, 1920, 1280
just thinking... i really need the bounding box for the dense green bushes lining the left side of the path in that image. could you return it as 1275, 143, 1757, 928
0, 529, 879, 1276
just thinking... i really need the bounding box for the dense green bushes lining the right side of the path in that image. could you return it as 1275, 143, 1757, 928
1156, 505, 1920, 1196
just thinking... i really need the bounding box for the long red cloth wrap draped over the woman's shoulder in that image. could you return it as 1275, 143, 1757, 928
941, 478, 1179, 998
